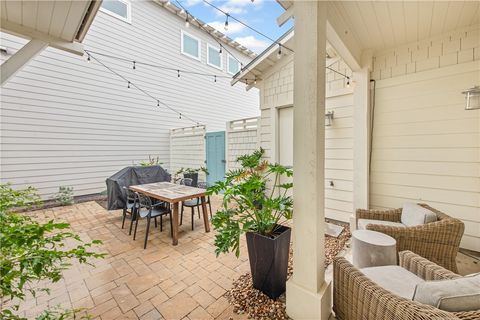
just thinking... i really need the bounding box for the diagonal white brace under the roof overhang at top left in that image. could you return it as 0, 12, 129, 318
0, 39, 48, 85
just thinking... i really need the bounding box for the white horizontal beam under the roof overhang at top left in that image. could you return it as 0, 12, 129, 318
0, 19, 84, 56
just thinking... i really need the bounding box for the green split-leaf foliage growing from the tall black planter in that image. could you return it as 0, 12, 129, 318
208, 149, 293, 257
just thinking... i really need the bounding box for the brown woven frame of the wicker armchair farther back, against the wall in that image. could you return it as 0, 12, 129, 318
356, 203, 465, 272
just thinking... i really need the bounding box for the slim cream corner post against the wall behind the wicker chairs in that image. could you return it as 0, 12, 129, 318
350, 67, 370, 230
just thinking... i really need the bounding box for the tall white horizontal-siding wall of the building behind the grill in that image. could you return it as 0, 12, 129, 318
0, 1, 258, 197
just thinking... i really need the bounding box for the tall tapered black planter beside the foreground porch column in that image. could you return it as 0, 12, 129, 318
246, 226, 291, 299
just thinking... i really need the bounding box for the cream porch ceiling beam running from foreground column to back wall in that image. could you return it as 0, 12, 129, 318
327, 3, 362, 71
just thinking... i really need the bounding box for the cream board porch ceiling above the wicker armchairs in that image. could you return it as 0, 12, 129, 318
330, 1, 480, 51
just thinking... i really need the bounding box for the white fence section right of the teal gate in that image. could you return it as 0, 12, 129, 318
225, 117, 260, 171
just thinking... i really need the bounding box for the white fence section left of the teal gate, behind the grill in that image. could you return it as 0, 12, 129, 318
170, 126, 206, 180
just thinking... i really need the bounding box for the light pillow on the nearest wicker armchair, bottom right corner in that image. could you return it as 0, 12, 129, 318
413, 274, 480, 312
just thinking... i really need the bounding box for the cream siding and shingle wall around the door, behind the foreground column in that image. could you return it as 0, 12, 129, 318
260, 56, 353, 221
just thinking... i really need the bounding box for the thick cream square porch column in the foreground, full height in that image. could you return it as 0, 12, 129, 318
286, 1, 331, 319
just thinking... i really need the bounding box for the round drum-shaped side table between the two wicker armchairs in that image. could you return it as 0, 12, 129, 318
352, 230, 397, 268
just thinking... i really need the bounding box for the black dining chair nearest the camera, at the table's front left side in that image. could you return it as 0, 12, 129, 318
132, 193, 172, 249
